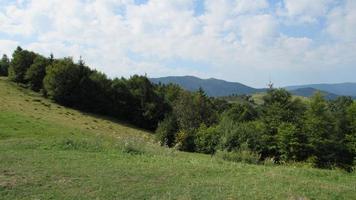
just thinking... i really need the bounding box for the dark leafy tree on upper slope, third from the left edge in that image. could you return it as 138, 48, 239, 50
25, 55, 50, 91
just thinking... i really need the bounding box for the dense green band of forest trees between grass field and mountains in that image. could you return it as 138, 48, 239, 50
0, 47, 356, 170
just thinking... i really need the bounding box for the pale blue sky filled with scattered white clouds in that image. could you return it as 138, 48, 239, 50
0, 0, 356, 87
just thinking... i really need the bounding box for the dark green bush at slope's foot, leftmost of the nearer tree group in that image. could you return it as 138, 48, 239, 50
156, 115, 178, 147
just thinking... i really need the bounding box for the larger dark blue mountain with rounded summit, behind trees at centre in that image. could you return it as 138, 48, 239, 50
150, 76, 263, 97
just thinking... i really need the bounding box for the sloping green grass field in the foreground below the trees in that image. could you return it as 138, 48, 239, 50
0, 78, 356, 200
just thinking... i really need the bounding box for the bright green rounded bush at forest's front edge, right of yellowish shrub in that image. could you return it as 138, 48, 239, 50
195, 124, 220, 154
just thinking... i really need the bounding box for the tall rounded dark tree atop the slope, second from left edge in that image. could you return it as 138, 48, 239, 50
9, 47, 37, 83
